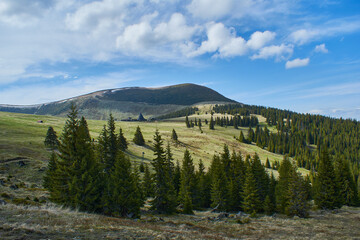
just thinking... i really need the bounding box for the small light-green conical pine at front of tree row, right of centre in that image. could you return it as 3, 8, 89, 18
242, 170, 261, 214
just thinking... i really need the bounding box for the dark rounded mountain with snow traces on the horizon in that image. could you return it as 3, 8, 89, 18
0, 83, 236, 119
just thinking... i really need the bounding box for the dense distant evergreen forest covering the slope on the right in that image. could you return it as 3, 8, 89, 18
213, 104, 360, 184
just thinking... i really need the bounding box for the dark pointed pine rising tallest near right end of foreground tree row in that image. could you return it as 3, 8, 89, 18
314, 149, 340, 209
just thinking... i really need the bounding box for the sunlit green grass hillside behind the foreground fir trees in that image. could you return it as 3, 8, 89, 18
0, 107, 307, 190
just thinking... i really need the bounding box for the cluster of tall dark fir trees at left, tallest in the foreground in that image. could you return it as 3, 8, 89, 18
44, 106, 144, 217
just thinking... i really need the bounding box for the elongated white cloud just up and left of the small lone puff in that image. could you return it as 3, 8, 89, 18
251, 44, 294, 61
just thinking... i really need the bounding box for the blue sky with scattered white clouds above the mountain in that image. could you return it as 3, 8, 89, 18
0, 0, 360, 120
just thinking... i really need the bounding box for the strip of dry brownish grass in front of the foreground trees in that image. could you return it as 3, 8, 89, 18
0, 204, 360, 239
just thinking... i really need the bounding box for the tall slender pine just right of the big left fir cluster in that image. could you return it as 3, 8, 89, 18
152, 130, 176, 214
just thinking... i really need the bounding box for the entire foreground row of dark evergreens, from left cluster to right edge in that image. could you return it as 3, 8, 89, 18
44, 107, 359, 217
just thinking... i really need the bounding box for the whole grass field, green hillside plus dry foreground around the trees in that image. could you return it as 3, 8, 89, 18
0, 112, 360, 239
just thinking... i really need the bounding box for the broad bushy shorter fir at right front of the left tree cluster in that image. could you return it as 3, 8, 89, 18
103, 151, 143, 217
